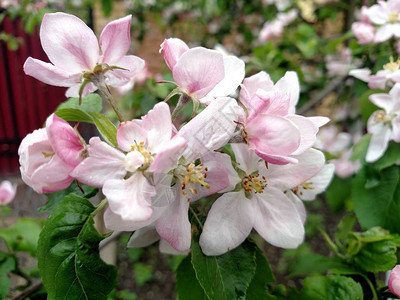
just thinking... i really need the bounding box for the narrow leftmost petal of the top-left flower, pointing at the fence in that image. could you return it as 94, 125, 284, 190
24, 57, 81, 87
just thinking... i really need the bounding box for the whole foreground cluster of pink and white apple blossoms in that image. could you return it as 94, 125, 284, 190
19, 13, 333, 255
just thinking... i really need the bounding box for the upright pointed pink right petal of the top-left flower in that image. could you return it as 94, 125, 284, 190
99, 15, 132, 65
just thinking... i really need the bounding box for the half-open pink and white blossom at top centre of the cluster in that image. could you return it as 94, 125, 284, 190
160, 38, 245, 104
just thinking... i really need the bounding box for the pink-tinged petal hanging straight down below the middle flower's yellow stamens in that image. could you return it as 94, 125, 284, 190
156, 193, 192, 251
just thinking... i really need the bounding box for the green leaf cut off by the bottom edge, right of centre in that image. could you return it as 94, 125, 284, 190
301, 275, 364, 300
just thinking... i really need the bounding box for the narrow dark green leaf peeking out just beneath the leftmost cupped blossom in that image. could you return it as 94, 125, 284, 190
38, 180, 99, 212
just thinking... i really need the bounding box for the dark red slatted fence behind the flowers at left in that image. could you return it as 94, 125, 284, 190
0, 18, 65, 175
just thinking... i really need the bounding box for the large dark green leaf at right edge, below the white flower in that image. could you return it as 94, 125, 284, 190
352, 166, 400, 233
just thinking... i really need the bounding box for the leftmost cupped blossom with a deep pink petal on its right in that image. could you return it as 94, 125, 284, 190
18, 114, 85, 194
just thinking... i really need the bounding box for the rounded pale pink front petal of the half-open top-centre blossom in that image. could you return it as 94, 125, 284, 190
172, 47, 225, 98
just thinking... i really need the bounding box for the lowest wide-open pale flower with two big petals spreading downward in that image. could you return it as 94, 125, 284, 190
200, 144, 325, 255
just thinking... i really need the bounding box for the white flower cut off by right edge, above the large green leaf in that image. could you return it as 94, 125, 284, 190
365, 83, 400, 162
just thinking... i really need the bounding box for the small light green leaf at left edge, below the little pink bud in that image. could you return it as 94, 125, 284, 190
0, 219, 42, 256
